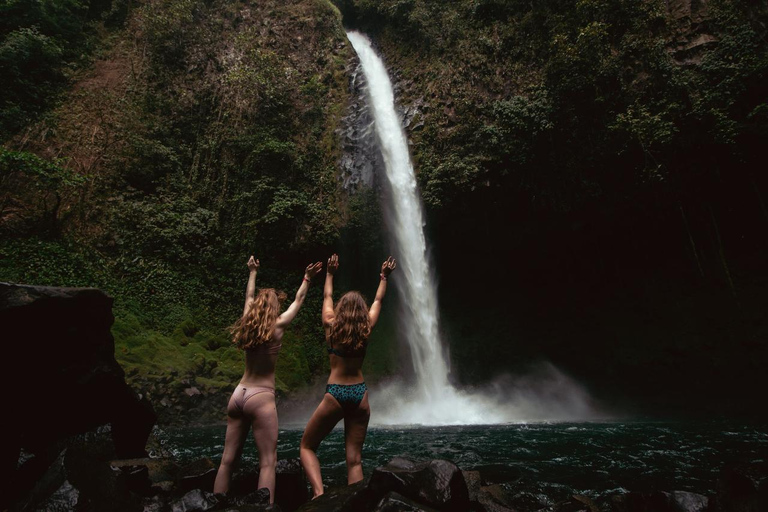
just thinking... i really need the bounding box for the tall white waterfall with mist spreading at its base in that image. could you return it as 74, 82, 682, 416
347, 32, 590, 425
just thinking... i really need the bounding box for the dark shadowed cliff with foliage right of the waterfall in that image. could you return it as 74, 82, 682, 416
336, 0, 768, 416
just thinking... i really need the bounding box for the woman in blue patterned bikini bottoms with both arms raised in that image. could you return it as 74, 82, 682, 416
301, 254, 397, 498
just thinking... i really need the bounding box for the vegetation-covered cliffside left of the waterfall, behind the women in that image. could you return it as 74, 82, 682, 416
0, 0, 382, 410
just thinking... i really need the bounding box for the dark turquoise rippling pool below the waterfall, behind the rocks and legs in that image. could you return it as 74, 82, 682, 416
166, 422, 768, 503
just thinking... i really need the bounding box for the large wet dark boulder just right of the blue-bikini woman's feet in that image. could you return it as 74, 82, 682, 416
369, 457, 469, 510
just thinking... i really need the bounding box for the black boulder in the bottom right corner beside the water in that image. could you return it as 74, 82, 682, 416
716, 462, 768, 512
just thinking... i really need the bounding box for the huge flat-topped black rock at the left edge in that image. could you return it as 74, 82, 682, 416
0, 283, 156, 507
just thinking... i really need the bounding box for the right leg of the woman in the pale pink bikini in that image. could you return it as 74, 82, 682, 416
244, 393, 278, 503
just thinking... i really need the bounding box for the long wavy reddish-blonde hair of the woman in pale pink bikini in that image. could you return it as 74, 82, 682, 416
229, 288, 285, 350
